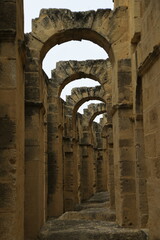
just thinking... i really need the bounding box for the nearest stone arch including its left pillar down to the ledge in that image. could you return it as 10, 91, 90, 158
25, 7, 128, 104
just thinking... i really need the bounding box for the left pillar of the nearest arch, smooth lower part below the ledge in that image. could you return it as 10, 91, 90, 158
25, 102, 46, 240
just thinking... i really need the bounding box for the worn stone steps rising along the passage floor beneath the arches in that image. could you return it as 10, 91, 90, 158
38, 193, 148, 240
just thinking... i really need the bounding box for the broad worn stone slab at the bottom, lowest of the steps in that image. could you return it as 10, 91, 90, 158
38, 220, 147, 240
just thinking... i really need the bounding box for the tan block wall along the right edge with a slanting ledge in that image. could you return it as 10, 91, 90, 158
132, 0, 160, 239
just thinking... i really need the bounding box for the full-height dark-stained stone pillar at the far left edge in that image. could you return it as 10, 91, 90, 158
0, 0, 24, 240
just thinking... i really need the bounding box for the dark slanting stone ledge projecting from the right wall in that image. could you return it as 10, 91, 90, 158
138, 44, 160, 76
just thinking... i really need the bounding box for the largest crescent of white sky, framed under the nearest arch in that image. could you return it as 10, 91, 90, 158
42, 40, 108, 78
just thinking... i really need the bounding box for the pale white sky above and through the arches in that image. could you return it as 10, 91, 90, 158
24, 0, 113, 120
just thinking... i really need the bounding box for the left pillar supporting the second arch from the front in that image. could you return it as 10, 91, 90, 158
47, 82, 63, 217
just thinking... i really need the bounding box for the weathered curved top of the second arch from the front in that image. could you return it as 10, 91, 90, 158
50, 59, 112, 96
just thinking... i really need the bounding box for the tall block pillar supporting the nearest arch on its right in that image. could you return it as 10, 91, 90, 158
113, 59, 137, 227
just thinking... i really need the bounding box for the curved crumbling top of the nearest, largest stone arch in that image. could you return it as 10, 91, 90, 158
30, 9, 113, 61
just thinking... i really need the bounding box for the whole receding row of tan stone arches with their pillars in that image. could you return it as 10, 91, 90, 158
25, 8, 148, 238
